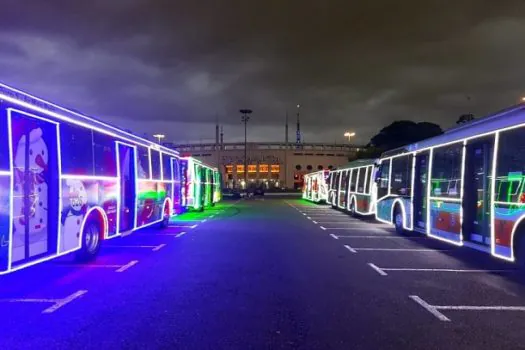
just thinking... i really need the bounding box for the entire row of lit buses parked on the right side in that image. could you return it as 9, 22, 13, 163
303, 104, 525, 264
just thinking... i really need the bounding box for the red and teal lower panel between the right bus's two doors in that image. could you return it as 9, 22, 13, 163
430, 200, 461, 243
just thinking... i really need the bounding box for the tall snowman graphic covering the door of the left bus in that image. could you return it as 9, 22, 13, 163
13, 128, 48, 260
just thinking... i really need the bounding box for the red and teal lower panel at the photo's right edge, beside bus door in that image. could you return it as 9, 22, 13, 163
494, 204, 525, 259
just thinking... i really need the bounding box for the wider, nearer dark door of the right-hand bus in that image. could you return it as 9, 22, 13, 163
463, 136, 494, 245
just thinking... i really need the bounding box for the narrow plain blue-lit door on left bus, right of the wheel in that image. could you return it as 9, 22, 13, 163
117, 143, 136, 232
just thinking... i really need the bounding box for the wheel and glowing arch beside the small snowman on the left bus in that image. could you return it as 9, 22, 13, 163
76, 206, 108, 262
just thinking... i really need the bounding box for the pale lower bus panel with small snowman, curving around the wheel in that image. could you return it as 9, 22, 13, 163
59, 178, 119, 253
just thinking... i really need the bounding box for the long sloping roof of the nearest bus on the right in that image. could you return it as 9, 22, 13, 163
381, 103, 525, 158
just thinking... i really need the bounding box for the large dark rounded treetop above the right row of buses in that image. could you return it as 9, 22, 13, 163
367, 120, 443, 151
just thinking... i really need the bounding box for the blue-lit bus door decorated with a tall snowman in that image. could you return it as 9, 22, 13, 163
10, 111, 60, 264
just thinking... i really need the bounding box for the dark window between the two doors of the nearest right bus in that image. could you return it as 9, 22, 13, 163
431, 143, 463, 198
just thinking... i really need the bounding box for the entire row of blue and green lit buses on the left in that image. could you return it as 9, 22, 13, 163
0, 84, 222, 274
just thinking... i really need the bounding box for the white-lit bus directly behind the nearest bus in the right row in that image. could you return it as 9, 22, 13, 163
330, 159, 376, 215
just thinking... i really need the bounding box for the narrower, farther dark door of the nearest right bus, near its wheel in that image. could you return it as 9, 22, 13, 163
413, 151, 430, 230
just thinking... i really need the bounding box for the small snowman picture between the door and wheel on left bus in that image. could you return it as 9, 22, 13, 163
60, 179, 87, 252
